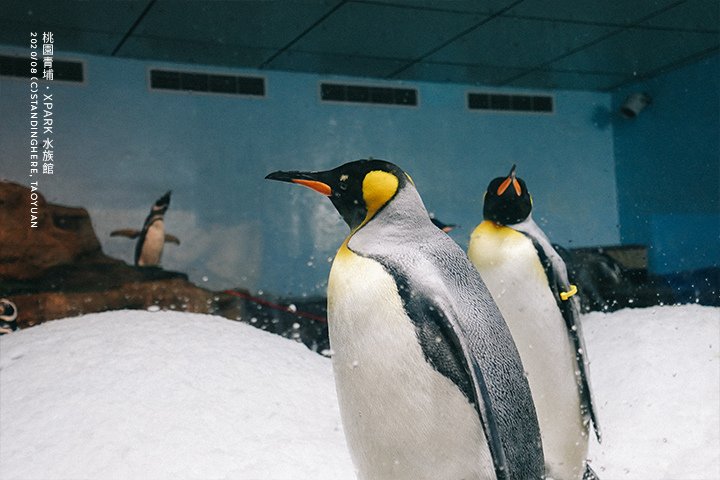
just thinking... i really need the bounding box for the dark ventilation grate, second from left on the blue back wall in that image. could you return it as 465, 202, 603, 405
149, 69, 265, 97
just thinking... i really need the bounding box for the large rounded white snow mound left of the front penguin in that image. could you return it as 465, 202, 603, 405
0, 310, 354, 480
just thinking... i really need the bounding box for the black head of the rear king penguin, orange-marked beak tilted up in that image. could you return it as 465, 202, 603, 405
483, 165, 532, 225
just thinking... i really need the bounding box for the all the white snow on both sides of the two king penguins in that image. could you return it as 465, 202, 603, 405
0, 305, 720, 480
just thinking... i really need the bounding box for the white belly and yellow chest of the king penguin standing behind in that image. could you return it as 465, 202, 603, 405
468, 227, 588, 480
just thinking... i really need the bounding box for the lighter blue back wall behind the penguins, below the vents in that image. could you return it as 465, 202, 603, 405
0, 48, 620, 295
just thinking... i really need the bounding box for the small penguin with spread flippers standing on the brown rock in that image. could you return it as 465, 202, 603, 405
110, 191, 180, 267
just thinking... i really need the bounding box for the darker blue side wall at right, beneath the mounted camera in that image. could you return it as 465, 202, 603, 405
613, 55, 720, 273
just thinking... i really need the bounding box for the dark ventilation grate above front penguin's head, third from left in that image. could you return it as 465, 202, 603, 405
320, 83, 418, 107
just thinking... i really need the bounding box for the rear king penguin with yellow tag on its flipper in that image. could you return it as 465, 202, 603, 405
468, 165, 600, 480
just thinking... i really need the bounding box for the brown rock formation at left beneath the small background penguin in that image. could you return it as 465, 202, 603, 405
0, 182, 244, 328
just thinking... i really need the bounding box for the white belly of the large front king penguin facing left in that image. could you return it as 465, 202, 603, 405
328, 247, 495, 480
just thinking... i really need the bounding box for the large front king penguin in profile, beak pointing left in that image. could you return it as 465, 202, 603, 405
266, 160, 544, 480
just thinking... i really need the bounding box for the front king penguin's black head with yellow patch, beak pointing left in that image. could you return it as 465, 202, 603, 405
265, 160, 411, 230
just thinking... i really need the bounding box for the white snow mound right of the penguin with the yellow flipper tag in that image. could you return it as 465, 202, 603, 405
583, 305, 720, 480
